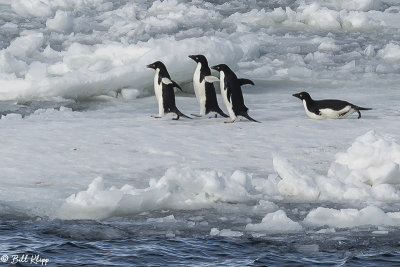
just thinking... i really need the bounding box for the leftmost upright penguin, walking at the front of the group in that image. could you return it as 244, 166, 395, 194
146, 61, 191, 120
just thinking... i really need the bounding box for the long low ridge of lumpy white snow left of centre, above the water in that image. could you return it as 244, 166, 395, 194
58, 169, 255, 219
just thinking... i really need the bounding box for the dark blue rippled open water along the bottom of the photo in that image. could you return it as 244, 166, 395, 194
0, 218, 400, 266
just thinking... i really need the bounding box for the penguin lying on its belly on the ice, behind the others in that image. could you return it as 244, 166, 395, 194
293, 92, 372, 120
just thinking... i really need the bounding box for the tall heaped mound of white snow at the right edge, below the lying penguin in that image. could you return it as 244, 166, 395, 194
271, 131, 400, 202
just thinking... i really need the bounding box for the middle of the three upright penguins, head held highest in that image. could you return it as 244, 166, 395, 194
189, 55, 229, 118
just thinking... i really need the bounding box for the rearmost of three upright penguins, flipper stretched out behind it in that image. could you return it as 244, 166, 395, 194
211, 64, 259, 123
